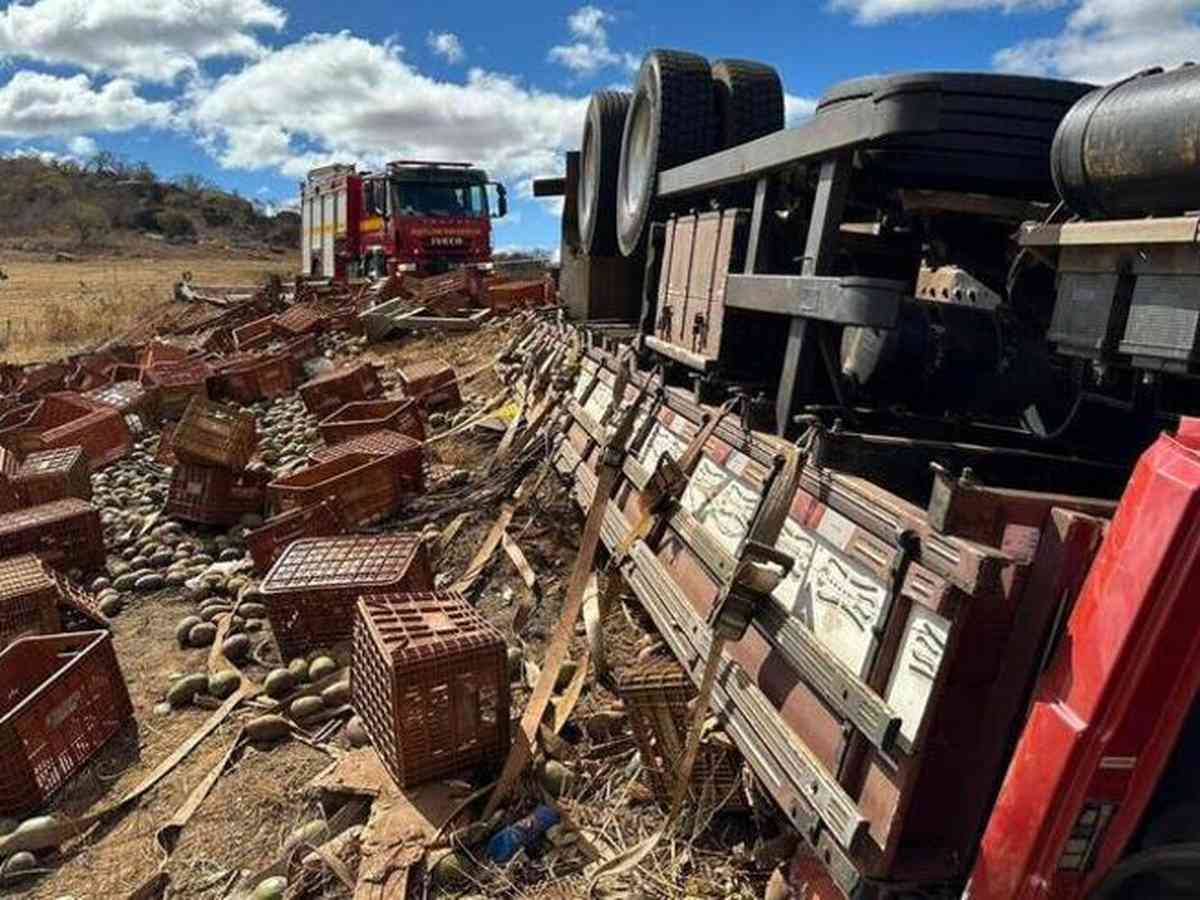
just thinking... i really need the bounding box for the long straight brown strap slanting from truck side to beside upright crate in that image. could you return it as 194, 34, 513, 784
482, 376, 646, 818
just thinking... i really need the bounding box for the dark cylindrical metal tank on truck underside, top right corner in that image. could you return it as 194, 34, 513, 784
1050, 65, 1200, 218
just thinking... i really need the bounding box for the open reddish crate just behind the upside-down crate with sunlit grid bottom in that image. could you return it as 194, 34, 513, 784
266, 454, 413, 528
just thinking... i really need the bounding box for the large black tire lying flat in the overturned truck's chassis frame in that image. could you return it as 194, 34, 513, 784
816, 72, 1091, 202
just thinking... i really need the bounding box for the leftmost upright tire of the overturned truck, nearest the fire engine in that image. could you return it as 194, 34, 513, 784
577, 91, 634, 257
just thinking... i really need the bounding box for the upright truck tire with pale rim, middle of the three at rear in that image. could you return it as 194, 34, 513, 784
617, 50, 713, 257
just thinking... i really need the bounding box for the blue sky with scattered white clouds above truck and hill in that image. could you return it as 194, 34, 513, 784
0, 0, 1200, 247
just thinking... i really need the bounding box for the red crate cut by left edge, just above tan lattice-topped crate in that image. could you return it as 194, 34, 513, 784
0, 497, 104, 571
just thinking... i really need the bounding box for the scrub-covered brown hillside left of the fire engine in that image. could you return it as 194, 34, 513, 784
0, 154, 300, 265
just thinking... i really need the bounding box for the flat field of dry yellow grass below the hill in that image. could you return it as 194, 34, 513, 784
0, 256, 290, 362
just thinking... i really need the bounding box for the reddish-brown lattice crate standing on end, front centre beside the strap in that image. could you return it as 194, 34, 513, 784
350, 592, 510, 787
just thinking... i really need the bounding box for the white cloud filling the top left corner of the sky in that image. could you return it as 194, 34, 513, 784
0, 0, 287, 82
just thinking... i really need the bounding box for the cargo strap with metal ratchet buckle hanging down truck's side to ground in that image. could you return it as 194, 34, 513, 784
588, 446, 808, 895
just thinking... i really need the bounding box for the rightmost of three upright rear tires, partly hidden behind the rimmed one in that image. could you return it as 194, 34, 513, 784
713, 59, 784, 150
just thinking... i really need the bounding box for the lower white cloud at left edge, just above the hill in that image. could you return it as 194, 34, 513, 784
0, 70, 173, 138
